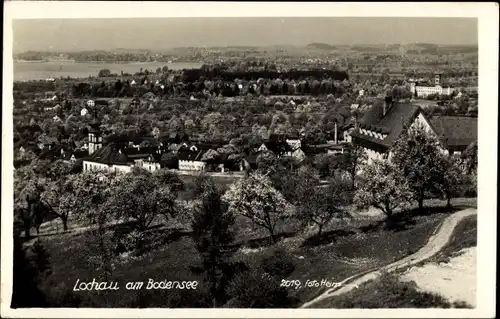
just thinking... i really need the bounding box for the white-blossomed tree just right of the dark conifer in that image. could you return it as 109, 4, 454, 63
223, 173, 292, 243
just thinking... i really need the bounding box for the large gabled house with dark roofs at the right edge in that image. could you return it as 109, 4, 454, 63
351, 97, 477, 163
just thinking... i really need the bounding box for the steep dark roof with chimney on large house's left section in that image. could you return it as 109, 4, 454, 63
351, 102, 421, 149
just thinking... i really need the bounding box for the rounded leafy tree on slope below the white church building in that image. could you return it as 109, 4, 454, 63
107, 170, 177, 231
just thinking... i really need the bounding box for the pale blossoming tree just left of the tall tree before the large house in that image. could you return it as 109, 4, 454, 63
354, 160, 413, 219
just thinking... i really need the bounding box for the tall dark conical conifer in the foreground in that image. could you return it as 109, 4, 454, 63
191, 179, 238, 308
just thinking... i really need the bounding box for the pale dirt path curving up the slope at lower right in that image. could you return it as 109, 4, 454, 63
300, 208, 477, 308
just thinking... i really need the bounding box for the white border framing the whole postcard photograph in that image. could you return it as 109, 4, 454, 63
1, 1, 499, 318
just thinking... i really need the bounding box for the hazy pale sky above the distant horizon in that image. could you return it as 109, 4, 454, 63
13, 17, 478, 52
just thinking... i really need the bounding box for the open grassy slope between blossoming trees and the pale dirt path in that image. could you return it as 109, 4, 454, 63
290, 213, 447, 302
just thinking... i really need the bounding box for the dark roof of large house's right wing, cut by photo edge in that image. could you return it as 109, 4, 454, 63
429, 116, 478, 149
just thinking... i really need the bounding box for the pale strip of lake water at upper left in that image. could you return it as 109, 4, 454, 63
14, 61, 202, 81
